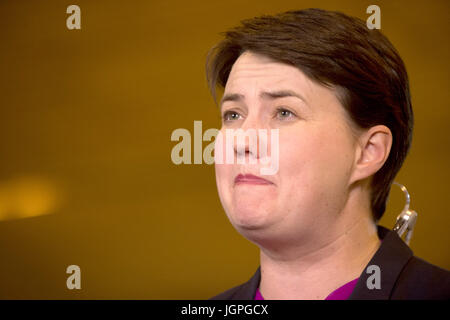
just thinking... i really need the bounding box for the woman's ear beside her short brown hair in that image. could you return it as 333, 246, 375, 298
349, 125, 392, 184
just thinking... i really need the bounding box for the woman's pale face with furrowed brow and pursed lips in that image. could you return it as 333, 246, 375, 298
215, 52, 356, 248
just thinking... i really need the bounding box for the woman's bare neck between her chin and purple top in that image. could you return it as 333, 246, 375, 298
260, 195, 381, 300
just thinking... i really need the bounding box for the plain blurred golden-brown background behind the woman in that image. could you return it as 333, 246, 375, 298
0, 0, 450, 299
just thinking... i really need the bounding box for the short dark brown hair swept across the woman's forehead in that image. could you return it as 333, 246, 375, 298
206, 9, 413, 221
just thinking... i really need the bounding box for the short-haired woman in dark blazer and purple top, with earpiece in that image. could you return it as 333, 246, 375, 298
207, 9, 450, 299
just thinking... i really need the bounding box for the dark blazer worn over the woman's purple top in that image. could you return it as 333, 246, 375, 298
211, 226, 450, 300
